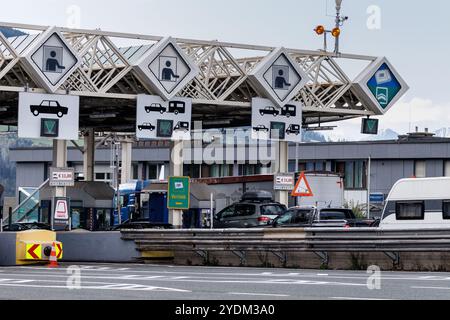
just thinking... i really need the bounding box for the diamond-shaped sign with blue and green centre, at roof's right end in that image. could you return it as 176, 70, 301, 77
354, 58, 409, 115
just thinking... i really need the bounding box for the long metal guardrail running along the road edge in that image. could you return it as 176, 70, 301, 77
122, 228, 450, 265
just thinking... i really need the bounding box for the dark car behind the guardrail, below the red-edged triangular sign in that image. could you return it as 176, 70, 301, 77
272, 207, 375, 228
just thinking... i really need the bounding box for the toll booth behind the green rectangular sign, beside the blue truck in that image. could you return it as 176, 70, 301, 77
142, 183, 214, 229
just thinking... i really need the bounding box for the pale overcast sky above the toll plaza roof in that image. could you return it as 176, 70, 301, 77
0, 0, 450, 139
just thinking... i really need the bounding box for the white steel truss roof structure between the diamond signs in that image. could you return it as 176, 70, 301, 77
0, 22, 376, 132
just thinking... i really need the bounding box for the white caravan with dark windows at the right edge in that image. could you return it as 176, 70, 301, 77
380, 178, 450, 230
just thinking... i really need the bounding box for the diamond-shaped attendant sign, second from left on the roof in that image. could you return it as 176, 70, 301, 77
134, 37, 199, 101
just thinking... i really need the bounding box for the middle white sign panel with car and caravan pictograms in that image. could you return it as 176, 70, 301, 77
136, 95, 192, 140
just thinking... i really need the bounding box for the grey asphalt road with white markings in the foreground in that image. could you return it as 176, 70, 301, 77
0, 264, 450, 300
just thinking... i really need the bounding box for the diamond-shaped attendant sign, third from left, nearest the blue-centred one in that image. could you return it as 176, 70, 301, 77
249, 48, 308, 107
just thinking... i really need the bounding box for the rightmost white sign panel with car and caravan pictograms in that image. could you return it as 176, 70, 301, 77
252, 98, 302, 143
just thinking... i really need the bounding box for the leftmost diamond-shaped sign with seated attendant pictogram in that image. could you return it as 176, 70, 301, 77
21, 28, 81, 93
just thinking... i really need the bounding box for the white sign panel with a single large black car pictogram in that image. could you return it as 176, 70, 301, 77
18, 92, 80, 140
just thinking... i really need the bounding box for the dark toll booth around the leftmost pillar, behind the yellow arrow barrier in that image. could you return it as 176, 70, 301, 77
39, 181, 114, 231
